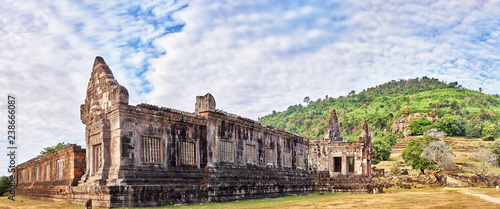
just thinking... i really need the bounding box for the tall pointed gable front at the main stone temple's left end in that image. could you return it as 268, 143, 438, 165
80, 57, 129, 185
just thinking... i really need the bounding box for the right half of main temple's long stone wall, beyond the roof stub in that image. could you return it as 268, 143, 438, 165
202, 111, 312, 202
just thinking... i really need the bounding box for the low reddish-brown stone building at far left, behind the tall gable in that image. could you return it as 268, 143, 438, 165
14, 144, 85, 201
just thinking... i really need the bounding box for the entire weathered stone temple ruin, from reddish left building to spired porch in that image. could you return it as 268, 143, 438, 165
15, 57, 381, 207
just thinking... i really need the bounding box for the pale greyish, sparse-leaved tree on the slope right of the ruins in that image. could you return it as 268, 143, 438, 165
422, 141, 455, 172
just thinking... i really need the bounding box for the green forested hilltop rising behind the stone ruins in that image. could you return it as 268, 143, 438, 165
259, 76, 500, 140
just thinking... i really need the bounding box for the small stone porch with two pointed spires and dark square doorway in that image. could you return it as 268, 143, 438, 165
308, 110, 374, 192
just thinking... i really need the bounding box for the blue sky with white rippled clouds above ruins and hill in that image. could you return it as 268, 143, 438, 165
0, 0, 500, 175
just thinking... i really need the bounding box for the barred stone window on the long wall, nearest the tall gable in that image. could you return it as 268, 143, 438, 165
141, 136, 163, 163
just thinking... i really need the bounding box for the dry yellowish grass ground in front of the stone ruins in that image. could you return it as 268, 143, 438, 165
0, 188, 500, 209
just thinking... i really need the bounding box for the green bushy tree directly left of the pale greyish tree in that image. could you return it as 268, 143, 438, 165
401, 135, 439, 174
